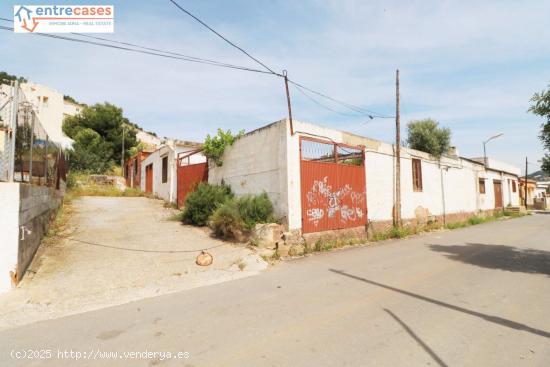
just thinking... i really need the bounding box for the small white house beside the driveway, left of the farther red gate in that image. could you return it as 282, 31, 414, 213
140, 140, 206, 203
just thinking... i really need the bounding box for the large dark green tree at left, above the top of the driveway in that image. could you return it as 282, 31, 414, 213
63, 102, 137, 172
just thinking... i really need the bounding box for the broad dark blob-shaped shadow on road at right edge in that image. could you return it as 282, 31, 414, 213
429, 243, 550, 276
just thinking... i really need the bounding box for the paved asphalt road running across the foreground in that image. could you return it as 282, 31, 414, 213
0, 214, 550, 367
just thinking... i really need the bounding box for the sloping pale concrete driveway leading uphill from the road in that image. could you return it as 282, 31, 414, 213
0, 197, 267, 329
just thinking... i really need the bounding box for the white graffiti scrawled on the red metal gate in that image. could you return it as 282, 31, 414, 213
306, 176, 365, 226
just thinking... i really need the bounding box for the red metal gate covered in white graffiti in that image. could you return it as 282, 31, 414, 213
300, 137, 367, 233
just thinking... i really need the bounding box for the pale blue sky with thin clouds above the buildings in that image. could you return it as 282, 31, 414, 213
0, 0, 550, 171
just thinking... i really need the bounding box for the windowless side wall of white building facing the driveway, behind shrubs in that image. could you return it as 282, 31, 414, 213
208, 121, 292, 222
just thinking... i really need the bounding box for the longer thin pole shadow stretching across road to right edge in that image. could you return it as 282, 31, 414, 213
329, 269, 550, 339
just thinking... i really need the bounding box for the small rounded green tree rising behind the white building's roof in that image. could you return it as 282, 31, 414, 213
407, 118, 451, 158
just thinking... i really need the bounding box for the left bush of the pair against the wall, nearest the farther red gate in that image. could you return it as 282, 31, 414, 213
183, 183, 233, 226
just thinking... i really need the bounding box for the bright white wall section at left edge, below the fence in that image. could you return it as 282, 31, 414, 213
0, 182, 20, 293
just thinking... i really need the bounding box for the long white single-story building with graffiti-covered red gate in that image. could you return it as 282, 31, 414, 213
208, 119, 520, 237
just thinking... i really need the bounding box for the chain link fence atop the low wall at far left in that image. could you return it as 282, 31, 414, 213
0, 83, 67, 189
